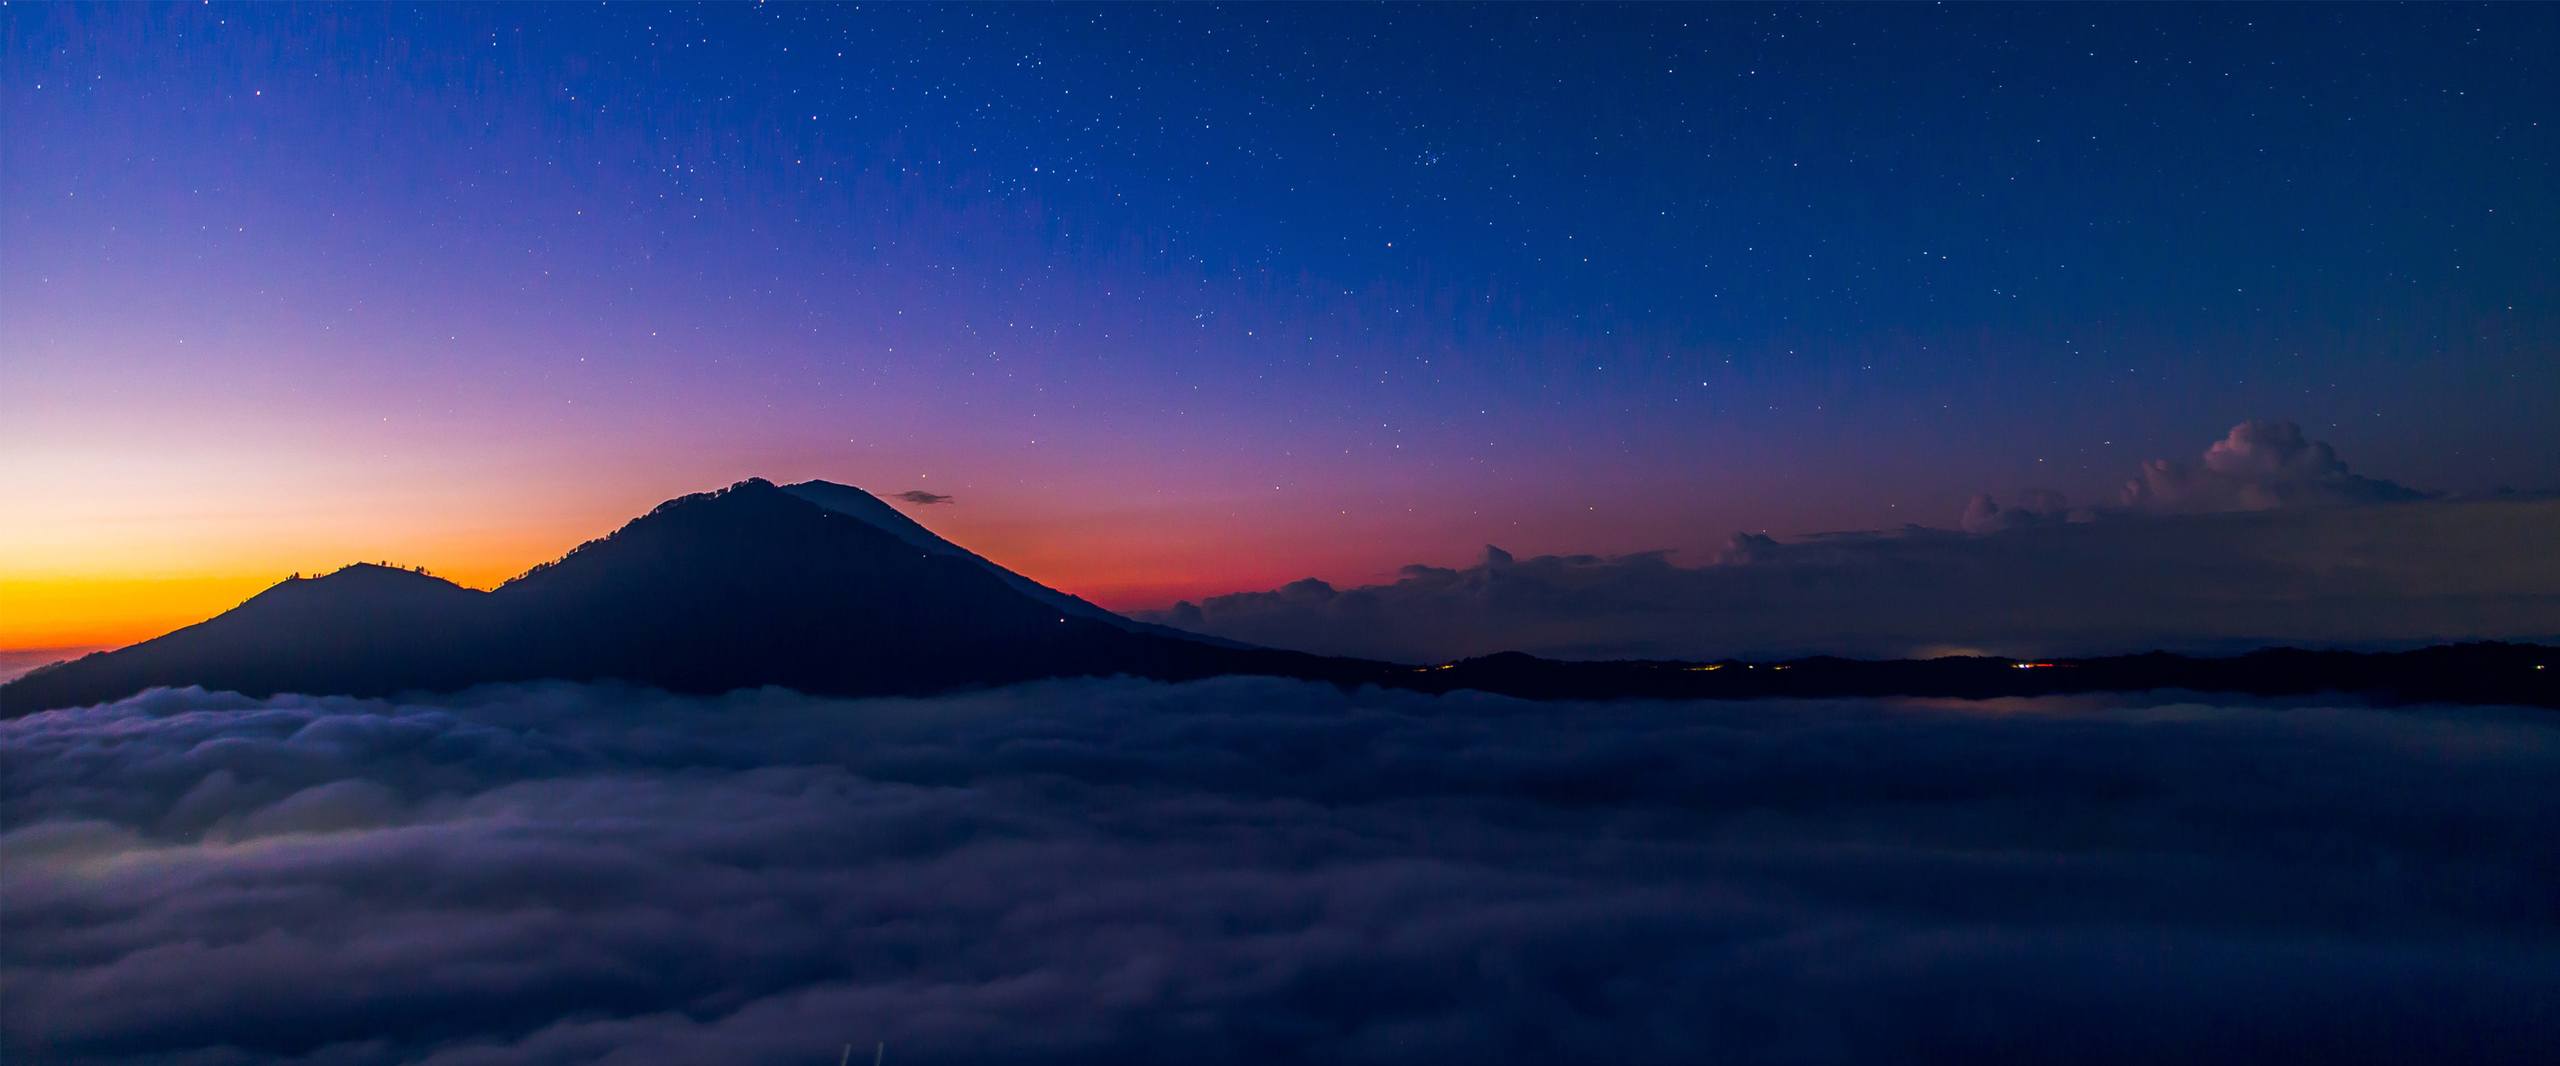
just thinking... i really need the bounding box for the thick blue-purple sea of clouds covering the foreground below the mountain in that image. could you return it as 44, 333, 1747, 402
0, 679, 2560, 1066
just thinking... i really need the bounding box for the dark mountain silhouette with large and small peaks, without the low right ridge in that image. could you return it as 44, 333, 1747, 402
0, 479, 1388, 715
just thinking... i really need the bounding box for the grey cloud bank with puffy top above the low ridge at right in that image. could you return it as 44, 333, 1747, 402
1144, 423, 2560, 661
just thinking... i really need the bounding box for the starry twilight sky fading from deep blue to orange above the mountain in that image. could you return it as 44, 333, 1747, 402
0, 5, 2560, 648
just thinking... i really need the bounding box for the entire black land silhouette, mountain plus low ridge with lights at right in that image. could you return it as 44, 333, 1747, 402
0, 479, 2560, 715
